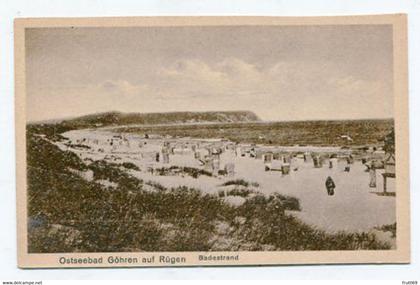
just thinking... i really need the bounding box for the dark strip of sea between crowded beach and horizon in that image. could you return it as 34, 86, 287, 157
117, 119, 394, 146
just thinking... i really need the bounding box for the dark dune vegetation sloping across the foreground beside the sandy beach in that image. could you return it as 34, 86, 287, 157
27, 126, 389, 253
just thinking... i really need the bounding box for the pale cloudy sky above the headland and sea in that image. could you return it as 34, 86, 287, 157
25, 25, 394, 121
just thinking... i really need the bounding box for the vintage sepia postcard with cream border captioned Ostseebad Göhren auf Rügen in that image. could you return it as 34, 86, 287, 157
15, 14, 410, 268
